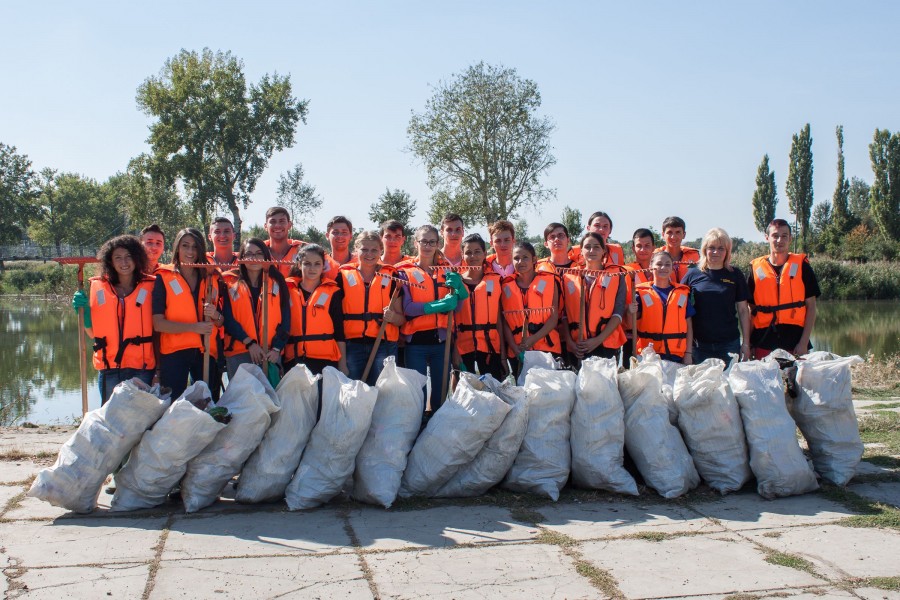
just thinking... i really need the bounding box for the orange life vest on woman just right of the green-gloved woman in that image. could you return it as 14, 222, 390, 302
455, 271, 503, 354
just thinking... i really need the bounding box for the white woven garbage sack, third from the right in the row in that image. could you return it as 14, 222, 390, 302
674, 358, 752, 494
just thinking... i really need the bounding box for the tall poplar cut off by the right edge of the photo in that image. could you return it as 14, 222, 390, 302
869, 129, 900, 240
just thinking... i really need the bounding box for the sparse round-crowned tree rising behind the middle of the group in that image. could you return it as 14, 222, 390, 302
407, 62, 556, 225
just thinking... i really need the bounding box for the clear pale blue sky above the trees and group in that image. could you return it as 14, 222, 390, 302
0, 0, 900, 241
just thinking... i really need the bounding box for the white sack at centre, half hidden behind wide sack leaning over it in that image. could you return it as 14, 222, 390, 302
435, 373, 528, 498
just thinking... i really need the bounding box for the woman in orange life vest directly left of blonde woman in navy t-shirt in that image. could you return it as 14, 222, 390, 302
629, 250, 694, 365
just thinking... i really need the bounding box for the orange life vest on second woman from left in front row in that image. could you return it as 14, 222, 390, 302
156, 268, 221, 357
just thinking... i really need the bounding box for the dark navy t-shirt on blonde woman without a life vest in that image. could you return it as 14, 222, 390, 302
681, 267, 749, 344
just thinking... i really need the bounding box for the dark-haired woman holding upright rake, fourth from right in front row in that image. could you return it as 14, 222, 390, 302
562, 231, 627, 359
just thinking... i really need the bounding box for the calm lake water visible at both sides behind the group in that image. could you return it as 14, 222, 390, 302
0, 298, 900, 425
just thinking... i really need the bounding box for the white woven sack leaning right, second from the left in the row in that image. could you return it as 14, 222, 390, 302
111, 381, 225, 511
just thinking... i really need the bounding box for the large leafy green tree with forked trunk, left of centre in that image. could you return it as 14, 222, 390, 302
137, 48, 308, 244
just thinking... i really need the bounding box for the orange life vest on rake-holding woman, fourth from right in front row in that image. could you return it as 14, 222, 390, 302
563, 266, 625, 348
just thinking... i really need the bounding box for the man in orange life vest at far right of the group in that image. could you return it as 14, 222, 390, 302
747, 219, 821, 359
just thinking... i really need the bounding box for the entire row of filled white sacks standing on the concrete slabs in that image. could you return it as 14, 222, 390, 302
28, 349, 863, 513
